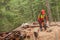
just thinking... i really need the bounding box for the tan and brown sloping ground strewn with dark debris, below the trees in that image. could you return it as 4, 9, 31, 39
0, 22, 60, 40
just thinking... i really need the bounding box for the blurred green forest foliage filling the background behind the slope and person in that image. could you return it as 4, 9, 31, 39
0, 0, 60, 32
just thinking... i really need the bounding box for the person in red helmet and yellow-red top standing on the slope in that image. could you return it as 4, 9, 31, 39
38, 9, 48, 31
